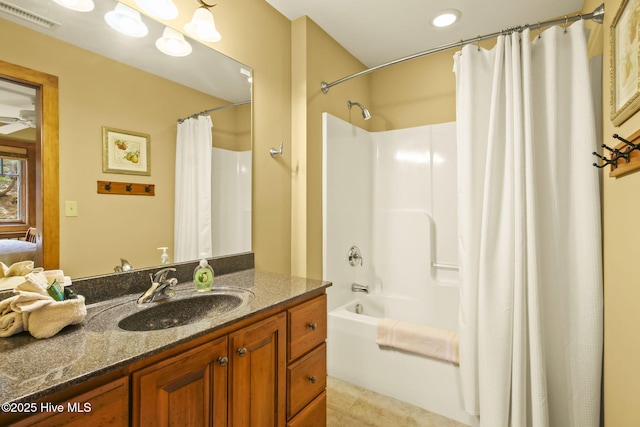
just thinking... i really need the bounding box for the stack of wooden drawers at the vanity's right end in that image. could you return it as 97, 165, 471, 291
287, 294, 327, 427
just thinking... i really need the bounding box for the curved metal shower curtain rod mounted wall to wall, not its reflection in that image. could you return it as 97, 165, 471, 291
320, 3, 604, 94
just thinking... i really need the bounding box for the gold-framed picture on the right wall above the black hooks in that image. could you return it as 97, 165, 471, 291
610, 0, 640, 126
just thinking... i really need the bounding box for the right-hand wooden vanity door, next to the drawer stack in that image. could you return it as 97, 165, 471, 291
229, 313, 287, 427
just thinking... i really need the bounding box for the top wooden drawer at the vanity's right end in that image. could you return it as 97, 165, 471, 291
288, 294, 327, 361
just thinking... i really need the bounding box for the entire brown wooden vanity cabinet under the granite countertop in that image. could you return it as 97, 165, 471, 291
14, 294, 327, 427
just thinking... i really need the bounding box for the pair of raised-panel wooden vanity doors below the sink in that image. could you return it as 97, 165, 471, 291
132, 313, 286, 427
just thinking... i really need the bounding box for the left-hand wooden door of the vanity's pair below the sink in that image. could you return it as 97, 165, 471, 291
132, 337, 227, 427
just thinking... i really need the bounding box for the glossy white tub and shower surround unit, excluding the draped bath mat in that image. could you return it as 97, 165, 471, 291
323, 113, 475, 425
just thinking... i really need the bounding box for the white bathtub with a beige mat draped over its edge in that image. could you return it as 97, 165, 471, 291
327, 293, 477, 426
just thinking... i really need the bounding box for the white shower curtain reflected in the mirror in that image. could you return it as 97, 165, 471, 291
174, 116, 212, 262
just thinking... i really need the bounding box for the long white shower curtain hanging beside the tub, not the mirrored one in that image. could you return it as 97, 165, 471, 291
455, 22, 603, 427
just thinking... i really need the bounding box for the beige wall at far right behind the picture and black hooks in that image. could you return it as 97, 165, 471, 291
600, 0, 640, 427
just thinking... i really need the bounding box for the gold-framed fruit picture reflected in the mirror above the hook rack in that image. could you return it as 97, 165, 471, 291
102, 126, 151, 176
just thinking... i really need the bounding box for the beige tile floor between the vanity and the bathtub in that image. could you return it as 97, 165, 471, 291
327, 377, 465, 427
